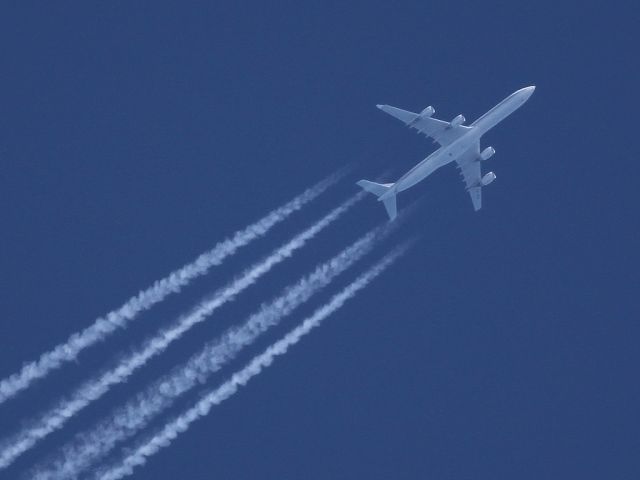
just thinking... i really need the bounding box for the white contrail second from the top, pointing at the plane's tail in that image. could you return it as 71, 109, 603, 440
0, 193, 364, 469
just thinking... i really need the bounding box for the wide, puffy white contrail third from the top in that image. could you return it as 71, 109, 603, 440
33, 222, 399, 480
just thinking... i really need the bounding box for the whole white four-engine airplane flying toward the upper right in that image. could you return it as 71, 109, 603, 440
357, 86, 536, 220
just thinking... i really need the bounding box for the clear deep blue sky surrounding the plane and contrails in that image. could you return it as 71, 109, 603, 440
0, 1, 640, 479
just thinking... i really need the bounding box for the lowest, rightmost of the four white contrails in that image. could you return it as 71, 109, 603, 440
94, 244, 409, 480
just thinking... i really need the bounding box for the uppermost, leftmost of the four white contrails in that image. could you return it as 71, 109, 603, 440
0, 170, 345, 405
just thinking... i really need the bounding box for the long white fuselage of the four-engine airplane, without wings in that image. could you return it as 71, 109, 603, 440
378, 87, 535, 201
